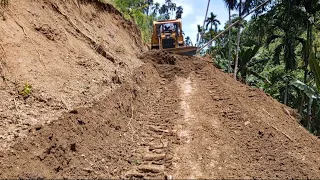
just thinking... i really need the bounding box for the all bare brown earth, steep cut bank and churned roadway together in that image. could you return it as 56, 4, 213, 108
0, 0, 320, 179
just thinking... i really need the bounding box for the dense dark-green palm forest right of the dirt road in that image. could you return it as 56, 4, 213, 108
197, 0, 320, 135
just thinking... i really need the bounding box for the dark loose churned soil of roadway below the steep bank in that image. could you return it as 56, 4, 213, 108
0, 51, 320, 179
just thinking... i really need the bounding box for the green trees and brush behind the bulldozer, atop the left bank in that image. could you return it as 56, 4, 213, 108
111, 0, 183, 43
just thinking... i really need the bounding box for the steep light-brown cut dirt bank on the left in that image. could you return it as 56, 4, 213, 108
0, 0, 144, 149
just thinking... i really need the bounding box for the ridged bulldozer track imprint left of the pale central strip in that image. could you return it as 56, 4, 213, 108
125, 79, 179, 179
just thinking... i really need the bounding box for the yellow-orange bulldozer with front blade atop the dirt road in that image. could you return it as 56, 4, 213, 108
151, 19, 197, 56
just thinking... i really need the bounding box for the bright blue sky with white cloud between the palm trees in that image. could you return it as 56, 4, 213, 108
154, 0, 239, 43
